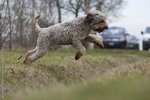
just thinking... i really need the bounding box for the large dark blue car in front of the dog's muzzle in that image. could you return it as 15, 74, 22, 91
102, 27, 128, 48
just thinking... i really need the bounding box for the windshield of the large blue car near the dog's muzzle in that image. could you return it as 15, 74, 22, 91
104, 28, 123, 35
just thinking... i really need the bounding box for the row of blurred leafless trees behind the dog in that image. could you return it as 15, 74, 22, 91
0, 0, 125, 50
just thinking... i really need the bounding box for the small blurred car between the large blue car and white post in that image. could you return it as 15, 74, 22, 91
127, 35, 139, 49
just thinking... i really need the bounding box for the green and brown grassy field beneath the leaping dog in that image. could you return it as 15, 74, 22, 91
0, 49, 150, 100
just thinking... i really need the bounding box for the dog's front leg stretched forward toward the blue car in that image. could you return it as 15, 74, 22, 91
83, 34, 104, 48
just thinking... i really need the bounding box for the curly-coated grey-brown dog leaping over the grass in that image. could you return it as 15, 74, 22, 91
24, 11, 108, 64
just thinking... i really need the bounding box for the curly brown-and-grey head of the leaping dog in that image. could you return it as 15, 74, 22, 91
86, 11, 108, 32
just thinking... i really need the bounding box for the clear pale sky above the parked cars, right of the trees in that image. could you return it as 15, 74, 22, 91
110, 0, 150, 37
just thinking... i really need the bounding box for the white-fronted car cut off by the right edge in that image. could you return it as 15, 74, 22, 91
141, 27, 150, 50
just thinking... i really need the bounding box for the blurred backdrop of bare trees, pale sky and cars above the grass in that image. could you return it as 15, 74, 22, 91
0, 0, 150, 50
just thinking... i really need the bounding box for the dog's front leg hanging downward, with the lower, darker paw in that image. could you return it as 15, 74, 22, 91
73, 40, 86, 60
